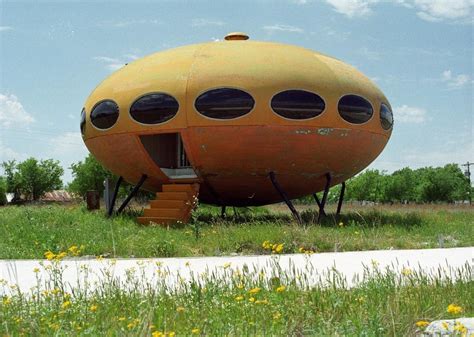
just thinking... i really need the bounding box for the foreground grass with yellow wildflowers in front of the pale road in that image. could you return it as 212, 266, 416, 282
0, 262, 474, 336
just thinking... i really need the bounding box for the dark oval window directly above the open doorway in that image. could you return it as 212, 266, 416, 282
130, 93, 179, 124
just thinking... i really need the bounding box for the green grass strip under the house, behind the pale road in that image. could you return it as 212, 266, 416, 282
0, 205, 474, 259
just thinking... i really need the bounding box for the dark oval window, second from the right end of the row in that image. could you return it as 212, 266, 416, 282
337, 95, 374, 124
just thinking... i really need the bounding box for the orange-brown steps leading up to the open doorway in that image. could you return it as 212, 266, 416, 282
137, 183, 199, 226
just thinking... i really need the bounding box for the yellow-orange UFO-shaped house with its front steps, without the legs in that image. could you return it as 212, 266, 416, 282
81, 33, 393, 223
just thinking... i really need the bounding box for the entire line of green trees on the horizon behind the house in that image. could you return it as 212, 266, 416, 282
0, 154, 473, 205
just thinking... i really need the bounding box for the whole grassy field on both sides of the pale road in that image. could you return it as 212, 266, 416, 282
0, 201, 474, 337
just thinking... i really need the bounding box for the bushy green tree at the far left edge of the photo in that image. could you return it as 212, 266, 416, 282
2, 158, 64, 200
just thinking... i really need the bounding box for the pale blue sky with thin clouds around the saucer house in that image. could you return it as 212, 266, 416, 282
0, 0, 474, 182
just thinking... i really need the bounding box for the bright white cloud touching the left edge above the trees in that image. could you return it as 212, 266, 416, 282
0, 94, 35, 128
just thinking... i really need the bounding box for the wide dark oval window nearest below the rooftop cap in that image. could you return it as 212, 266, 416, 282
194, 88, 255, 119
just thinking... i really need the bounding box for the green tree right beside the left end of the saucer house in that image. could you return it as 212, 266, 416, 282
68, 154, 115, 196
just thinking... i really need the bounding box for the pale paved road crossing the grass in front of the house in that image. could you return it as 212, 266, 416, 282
0, 247, 474, 295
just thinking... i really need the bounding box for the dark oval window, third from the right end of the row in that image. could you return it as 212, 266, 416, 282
271, 90, 325, 119
